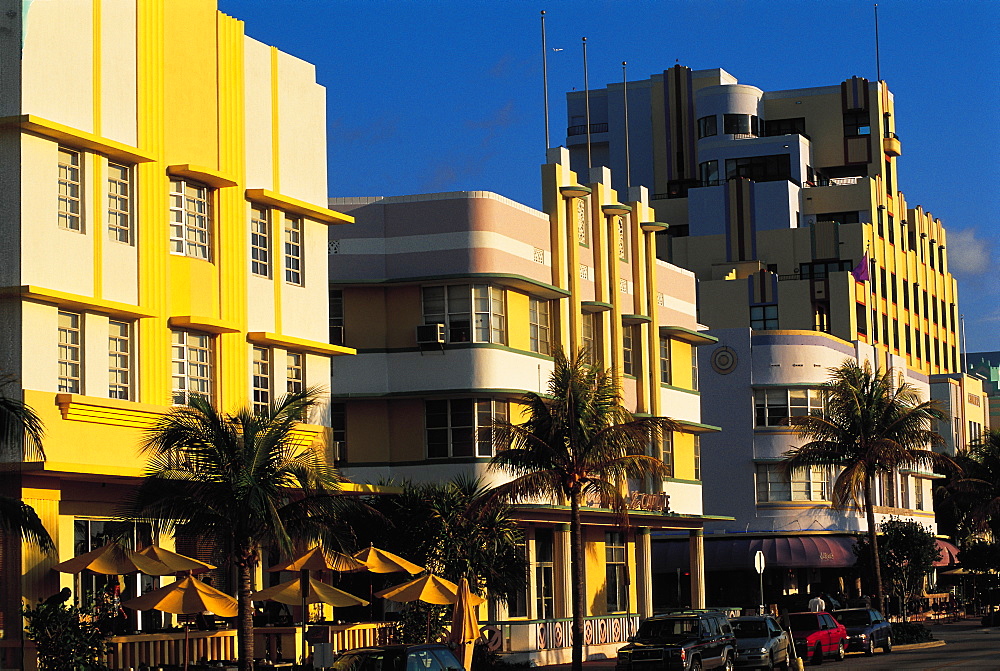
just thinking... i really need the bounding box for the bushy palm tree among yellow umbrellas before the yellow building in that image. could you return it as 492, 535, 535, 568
128, 389, 352, 671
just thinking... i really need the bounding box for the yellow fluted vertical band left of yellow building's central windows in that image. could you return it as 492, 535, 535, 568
135, 0, 170, 404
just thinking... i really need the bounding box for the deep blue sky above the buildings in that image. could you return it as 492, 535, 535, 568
219, 0, 1000, 352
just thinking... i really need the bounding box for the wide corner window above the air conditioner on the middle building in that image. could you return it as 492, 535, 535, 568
423, 284, 507, 344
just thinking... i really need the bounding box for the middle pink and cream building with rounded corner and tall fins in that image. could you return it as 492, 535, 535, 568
330, 148, 728, 662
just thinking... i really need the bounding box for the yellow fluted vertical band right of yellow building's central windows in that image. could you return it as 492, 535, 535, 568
216, 13, 250, 408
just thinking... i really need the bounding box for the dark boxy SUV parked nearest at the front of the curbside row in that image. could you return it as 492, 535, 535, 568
615, 610, 736, 671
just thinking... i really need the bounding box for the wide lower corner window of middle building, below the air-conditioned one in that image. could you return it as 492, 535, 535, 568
424, 398, 508, 459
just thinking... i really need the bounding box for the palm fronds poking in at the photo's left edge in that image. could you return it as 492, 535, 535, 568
0, 394, 55, 552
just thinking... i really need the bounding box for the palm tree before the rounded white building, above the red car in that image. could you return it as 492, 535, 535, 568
784, 359, 953, 608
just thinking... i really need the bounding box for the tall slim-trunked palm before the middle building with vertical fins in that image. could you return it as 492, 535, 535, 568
492, 351, 678, 671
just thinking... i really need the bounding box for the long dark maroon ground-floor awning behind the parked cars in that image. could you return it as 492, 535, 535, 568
653, 535, 855, 573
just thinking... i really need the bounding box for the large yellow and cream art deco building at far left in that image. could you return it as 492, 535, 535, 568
0, 0, 353, 668
